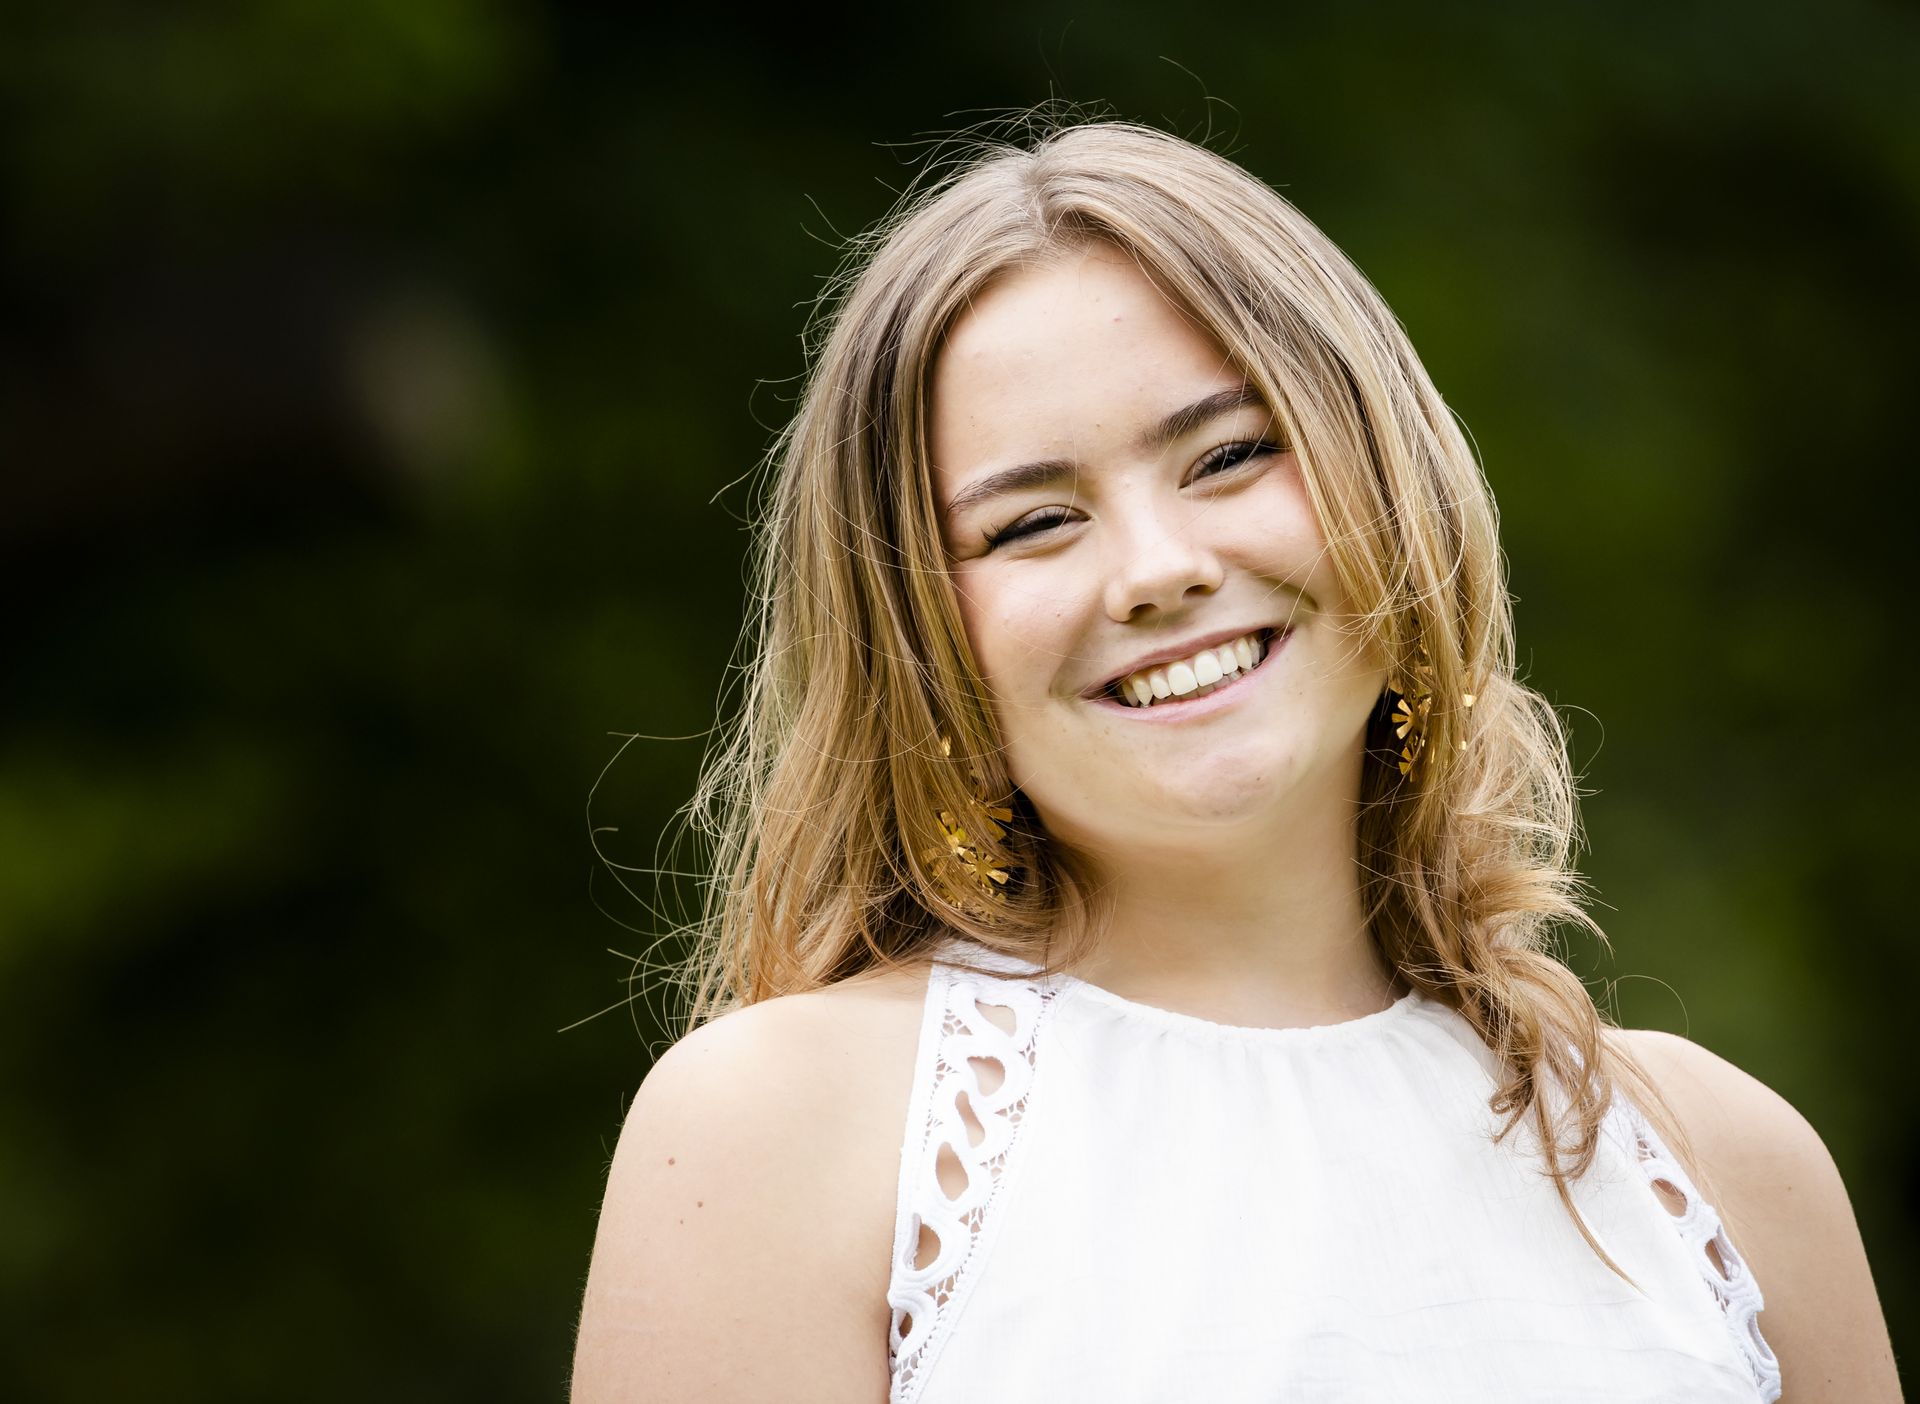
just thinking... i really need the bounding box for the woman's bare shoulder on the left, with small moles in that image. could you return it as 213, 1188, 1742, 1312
572, 970, 925, 1404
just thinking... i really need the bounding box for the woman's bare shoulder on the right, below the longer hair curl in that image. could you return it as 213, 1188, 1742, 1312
1609, 1029, 1901, 1404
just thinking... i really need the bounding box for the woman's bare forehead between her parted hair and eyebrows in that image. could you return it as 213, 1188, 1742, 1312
929, 246, 1240, 480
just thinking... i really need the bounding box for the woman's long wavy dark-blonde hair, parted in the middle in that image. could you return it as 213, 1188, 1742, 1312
682, 119, 1693, 1277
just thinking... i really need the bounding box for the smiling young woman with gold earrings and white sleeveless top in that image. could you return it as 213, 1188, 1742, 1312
574, 123, 1899, 1404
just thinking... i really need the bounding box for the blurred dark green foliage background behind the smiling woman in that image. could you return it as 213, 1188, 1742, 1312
0, 0, 1920, 1400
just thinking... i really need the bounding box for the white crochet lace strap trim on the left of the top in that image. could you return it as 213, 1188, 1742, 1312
887, 948, 1054, 1404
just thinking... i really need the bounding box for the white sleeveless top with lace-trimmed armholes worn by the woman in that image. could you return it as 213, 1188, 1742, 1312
887, 943, 1780, 1404
